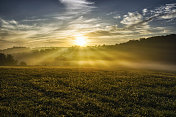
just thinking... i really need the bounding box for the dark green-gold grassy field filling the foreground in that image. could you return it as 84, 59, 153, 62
0, 67, 176, 117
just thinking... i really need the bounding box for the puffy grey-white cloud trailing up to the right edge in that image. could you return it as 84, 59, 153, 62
120, 3, 176, 29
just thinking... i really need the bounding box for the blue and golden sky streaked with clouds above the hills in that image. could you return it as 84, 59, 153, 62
0, 0, 176, 49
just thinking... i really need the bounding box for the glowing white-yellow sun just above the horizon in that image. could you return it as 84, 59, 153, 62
74, 36, 87, 46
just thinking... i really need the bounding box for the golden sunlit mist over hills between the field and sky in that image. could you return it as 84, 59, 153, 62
1, 35, 176, 70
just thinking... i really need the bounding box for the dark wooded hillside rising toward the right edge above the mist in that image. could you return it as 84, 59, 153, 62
108, 34, 176, 64
